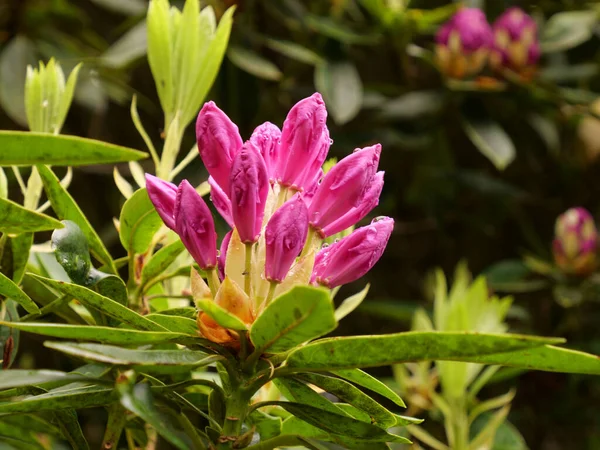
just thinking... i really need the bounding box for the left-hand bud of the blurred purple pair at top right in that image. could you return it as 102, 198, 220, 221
436, 8, 494, 78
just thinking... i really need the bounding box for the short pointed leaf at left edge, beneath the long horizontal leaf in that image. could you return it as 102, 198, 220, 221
0, 198, 62, 234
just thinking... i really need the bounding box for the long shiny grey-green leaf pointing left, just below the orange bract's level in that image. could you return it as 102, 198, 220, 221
44, 342, 223, 372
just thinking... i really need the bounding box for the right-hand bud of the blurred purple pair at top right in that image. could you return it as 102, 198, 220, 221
490, 7, 541, 72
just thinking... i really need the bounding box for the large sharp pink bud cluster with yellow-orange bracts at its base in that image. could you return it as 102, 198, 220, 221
147, 93, 394, 347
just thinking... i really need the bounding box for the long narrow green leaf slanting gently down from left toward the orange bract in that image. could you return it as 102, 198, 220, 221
30, 274, 166, 331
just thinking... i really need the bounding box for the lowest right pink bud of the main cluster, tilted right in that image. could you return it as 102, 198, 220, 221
311, 217, 394, 289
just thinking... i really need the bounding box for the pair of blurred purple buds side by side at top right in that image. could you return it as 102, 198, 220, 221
435, 7, 540, 78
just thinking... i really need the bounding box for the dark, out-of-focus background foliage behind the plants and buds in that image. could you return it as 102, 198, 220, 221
0, 0, 600, 450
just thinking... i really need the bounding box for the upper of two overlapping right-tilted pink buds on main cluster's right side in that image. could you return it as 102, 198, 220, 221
308, 144, 381, 236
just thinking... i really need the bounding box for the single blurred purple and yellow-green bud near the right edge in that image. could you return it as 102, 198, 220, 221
552, 208, 598, 275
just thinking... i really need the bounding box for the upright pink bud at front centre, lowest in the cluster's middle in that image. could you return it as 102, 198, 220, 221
265, 194, 308, 282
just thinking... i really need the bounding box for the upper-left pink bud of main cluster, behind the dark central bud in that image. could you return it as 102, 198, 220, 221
196, 102, 243, 192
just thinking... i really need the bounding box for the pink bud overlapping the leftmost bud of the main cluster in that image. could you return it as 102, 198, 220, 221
173, 180, 217, 269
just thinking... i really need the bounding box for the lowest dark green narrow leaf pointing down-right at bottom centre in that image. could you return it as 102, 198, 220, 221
264, 402, 406, 442
